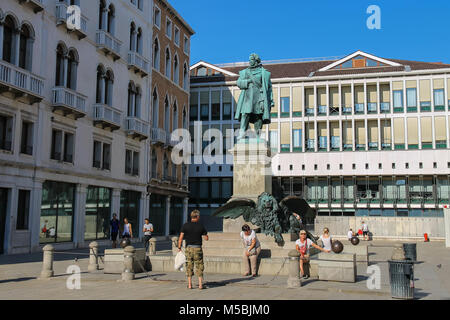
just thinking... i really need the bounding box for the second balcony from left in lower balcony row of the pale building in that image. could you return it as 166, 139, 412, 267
52, 87, 87, 119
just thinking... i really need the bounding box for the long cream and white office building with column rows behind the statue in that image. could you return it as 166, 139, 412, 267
189, 51, 450, 234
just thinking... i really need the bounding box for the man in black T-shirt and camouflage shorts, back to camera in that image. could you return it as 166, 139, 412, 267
178, 210, 209, 290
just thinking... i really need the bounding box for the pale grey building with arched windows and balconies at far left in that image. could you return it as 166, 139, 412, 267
0, 0, 189, 254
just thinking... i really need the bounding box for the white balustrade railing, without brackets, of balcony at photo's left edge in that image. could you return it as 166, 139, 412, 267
0, 60, 44, 96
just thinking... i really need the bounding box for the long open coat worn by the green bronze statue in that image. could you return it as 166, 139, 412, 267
235, 67, 274, 124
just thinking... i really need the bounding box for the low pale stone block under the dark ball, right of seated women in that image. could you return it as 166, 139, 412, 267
309, 253, 357, 282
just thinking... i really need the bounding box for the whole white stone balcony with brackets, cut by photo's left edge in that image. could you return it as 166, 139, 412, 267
0, 60, 44, 104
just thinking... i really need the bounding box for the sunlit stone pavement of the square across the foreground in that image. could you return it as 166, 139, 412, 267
0, 241, 450, 300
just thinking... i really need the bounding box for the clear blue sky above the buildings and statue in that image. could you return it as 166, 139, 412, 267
169, 0, 450, 64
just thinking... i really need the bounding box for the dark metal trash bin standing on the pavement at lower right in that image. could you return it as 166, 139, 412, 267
388, 260, 414, 300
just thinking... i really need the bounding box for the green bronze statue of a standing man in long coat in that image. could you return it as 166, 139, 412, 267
235, 53, 274, 140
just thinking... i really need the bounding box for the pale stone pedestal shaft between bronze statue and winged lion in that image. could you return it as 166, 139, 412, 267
230, 139, 272, 202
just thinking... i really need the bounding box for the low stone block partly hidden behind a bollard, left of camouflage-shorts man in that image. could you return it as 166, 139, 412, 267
103, 248, 149, 274
